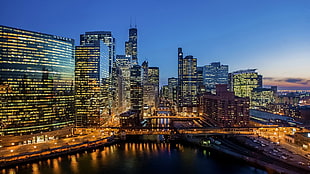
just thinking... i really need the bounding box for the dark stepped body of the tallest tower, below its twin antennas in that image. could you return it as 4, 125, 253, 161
125, 28, 138, 65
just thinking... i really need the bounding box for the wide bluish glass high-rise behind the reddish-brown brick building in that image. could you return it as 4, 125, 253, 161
203, 62, 228, 93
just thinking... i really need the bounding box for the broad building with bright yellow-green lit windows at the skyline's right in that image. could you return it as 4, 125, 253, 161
229, 69, 262, 97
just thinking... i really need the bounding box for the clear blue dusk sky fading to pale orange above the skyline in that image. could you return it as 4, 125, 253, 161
0, 0, 310, 89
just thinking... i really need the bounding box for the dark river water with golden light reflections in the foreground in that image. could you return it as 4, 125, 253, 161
1, 142, 267, 174
